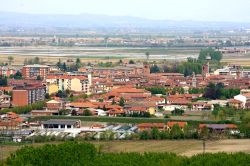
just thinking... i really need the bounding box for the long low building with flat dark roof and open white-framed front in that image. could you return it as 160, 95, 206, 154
41, 119, 81, 129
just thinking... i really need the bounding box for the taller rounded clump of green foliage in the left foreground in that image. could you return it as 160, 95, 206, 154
7, 142, 97, 166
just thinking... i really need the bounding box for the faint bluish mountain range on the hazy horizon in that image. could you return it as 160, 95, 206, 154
0, 12, 250, 30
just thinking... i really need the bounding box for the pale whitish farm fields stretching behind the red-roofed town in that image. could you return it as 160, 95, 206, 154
0, 46, 250, 66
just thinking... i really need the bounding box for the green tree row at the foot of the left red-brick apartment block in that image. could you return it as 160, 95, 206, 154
0, 101, 46, 114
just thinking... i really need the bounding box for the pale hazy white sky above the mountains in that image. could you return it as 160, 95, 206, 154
0, 0, 250, 22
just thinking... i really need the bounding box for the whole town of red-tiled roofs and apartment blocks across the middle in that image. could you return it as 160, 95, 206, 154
0, 50, 250, 142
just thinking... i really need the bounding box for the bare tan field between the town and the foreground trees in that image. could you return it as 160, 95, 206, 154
0, 139, 250, 161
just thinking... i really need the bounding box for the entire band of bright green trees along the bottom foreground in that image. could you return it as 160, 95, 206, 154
4, 142, 250, 166
